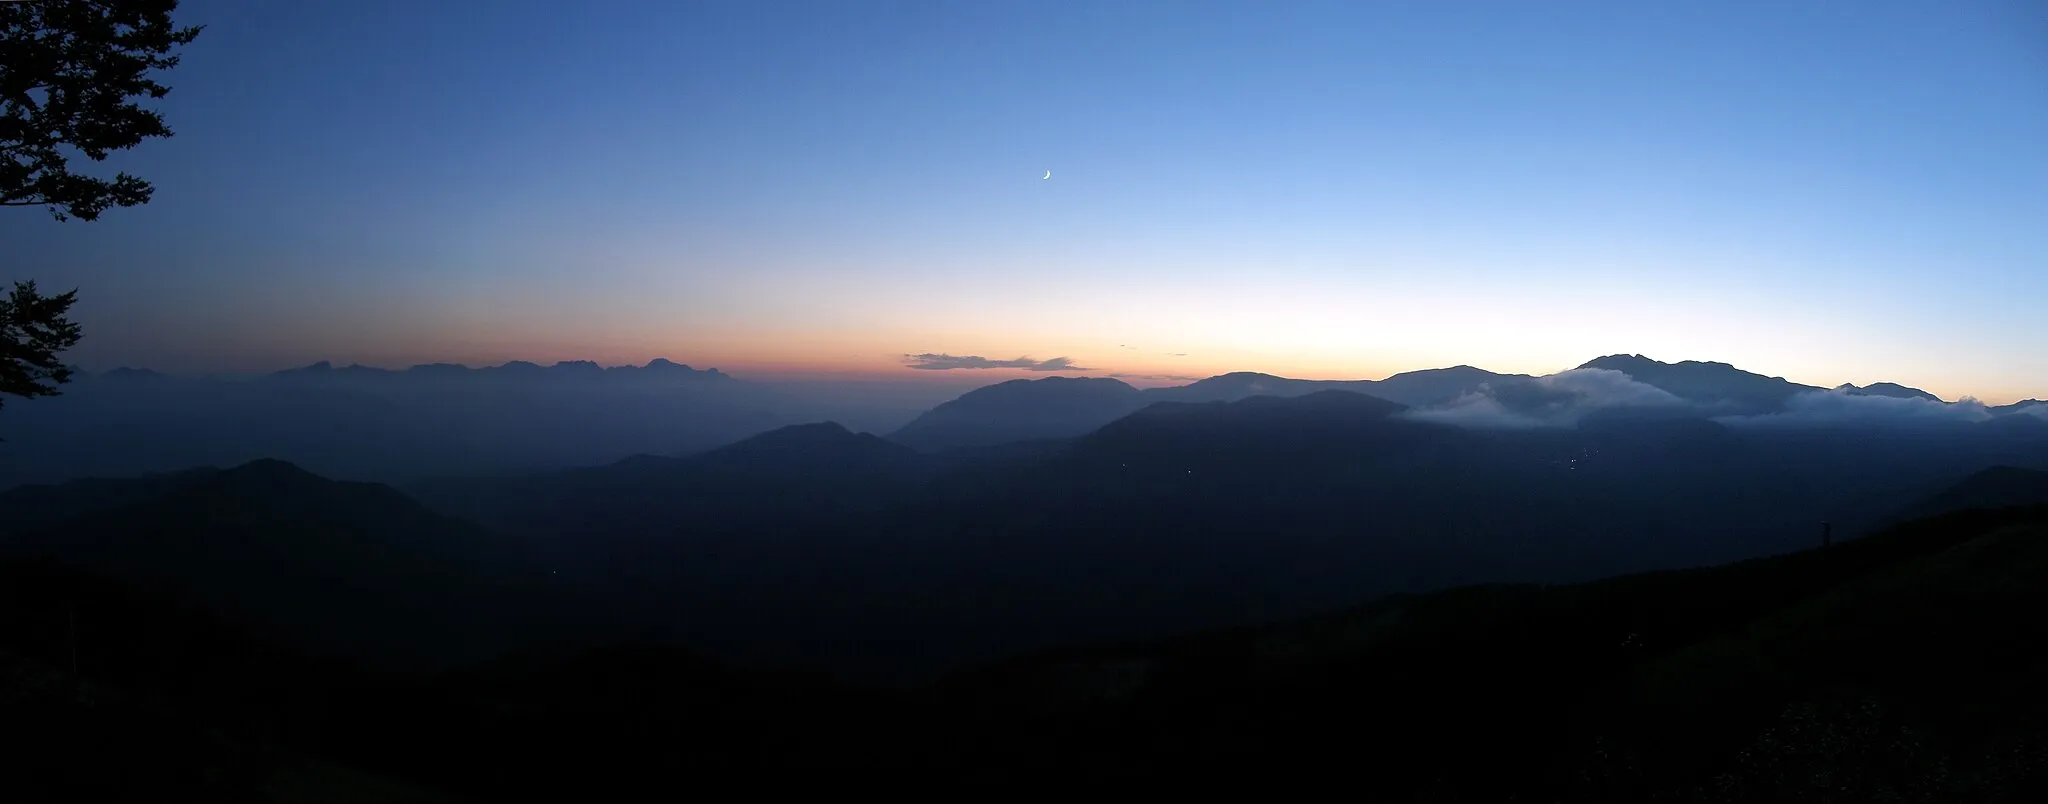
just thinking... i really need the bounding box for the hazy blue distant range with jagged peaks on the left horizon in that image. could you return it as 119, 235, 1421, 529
0, 360, 948, 489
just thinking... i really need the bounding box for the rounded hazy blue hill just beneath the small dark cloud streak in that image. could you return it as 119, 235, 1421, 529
889, 376, 1145, 450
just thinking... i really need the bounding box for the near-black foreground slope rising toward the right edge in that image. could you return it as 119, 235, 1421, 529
921, 507, 2048, 802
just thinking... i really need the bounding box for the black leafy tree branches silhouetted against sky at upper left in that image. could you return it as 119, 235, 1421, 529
0, 0, 201, 419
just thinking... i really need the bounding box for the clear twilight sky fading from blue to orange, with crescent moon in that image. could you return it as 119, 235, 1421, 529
0, 0, 2048, 403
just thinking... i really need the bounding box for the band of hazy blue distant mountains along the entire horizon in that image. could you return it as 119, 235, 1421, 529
0, 354, 2048, 489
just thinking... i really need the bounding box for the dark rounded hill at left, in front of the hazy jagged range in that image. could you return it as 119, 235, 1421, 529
0, 460, 565, 667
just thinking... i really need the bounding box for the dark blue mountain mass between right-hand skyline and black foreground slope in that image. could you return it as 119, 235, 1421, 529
380, 358, 2048, 675
